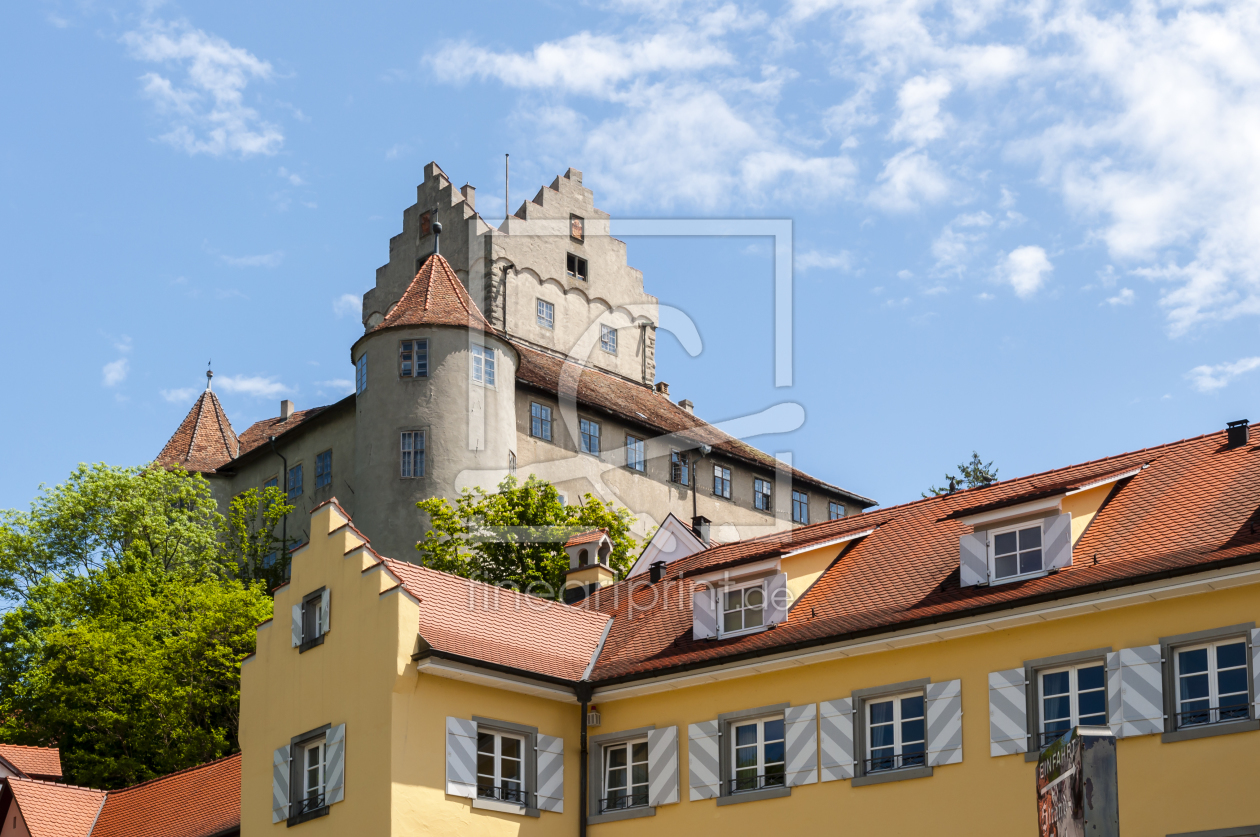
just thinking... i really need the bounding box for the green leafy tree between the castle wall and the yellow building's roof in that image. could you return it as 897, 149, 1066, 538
416, 475, 636, 597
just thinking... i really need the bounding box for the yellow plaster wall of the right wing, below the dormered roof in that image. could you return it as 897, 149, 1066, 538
591, 585, 1260, 837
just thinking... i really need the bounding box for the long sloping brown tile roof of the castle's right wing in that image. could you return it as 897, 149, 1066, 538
512, 342, 874, 508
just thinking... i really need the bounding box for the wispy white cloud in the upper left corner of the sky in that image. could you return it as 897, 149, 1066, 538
122, 20, 285, 158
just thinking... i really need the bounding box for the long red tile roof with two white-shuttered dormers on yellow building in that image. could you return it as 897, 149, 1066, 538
582, 421, 1260, 682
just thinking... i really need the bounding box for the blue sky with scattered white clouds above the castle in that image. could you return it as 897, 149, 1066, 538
0, 0, 1260, 508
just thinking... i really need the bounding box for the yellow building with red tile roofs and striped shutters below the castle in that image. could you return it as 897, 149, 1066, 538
241, 424, 1260, 837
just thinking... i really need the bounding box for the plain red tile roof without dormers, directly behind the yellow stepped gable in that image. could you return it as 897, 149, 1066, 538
383, 558, 609, 681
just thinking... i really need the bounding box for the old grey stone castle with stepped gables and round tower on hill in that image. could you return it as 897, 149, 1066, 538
156, 163, 874, 558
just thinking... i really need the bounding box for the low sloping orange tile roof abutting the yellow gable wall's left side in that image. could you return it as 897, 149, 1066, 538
91, 753, 241, 837
